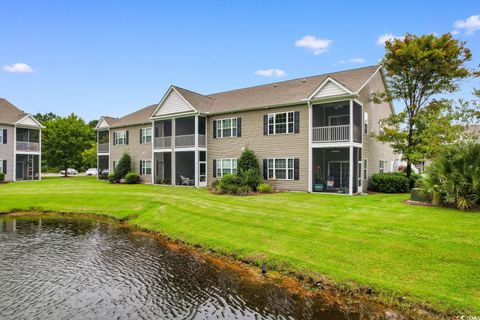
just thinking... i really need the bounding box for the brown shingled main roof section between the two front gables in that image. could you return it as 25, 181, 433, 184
152, 66, 379, 114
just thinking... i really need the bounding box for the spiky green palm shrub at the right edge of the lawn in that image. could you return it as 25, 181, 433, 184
420, 143, 480, 210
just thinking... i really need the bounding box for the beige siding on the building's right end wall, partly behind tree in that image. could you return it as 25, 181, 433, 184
359, 72, 396, 191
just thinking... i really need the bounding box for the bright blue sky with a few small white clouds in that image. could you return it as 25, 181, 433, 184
0, 0, 480, 120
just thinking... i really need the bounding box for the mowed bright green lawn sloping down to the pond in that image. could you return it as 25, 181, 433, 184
0, 177, 480, 315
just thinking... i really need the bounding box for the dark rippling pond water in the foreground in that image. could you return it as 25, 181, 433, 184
0, 217, 376, 319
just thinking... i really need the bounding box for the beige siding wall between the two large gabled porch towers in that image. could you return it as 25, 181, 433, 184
207, 104, 309, 191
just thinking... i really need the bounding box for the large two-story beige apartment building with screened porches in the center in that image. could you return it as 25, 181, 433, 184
97, 66, 396, 194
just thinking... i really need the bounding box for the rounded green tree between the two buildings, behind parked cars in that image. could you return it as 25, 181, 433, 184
42, 113, 95, 176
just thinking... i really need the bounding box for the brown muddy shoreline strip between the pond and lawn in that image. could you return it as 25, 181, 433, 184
0, 211, 446, 319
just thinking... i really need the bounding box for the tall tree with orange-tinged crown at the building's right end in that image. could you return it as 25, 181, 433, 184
374, 33, 472, 178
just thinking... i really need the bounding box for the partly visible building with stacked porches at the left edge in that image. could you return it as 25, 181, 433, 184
0, 98, 43, 181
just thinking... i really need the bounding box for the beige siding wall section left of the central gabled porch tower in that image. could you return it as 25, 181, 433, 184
108, 124, 153, 183
